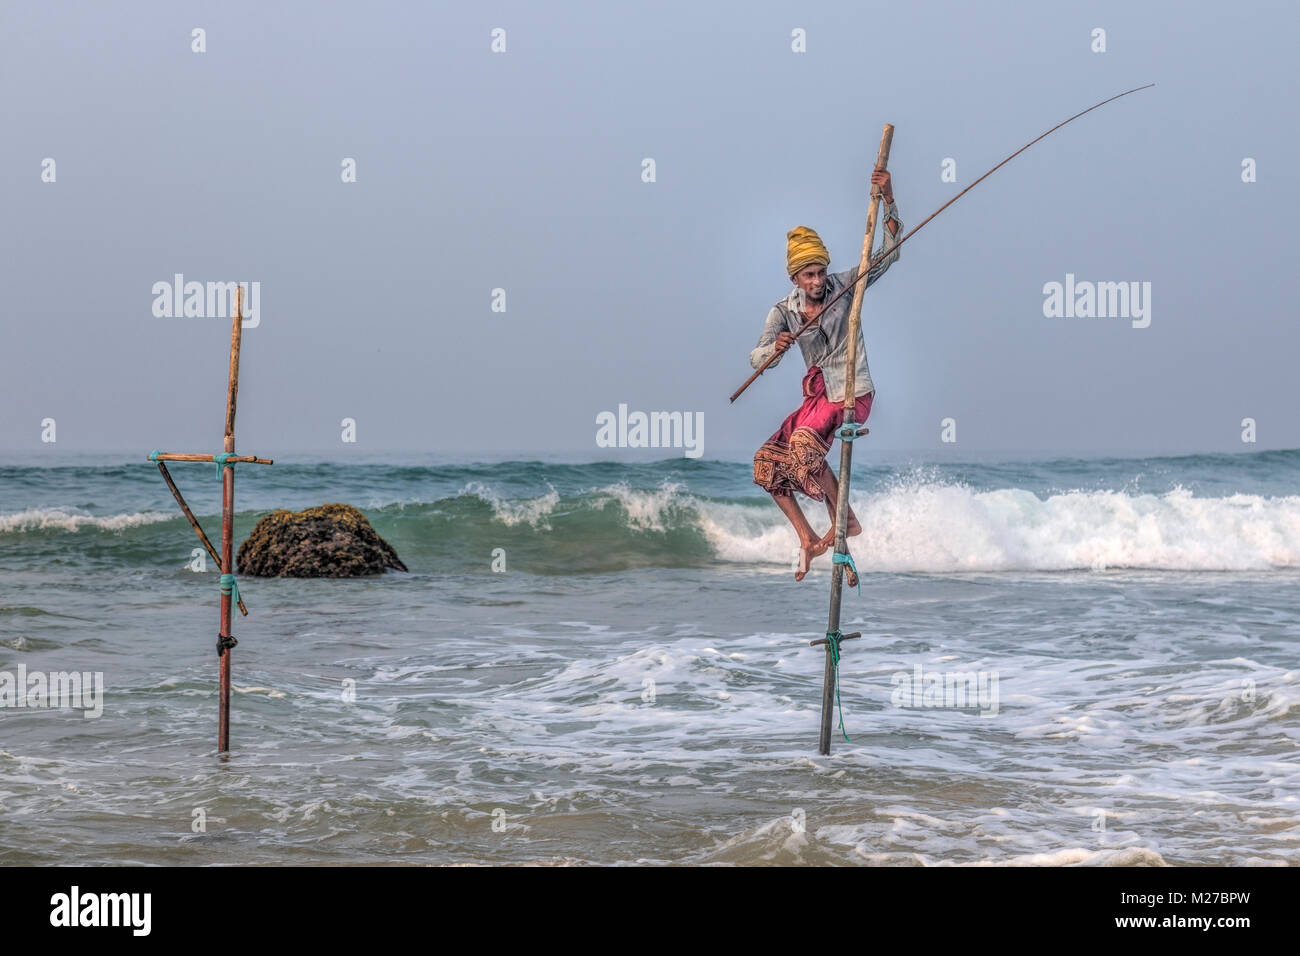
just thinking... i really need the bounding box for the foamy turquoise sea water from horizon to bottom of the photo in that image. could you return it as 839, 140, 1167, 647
0, 451, 1300, 865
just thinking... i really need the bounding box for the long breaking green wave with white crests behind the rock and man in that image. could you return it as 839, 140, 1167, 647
0, 468, 1300, 574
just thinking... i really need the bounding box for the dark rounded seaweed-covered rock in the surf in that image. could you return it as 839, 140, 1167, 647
238, 505, 407, 578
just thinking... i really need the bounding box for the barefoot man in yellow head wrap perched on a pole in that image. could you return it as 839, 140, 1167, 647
749, 169, 904, 588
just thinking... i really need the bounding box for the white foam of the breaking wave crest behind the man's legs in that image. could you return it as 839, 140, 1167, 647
698, 481, 1300, 572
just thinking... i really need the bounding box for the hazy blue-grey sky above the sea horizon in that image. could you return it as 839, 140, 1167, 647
0, 0, 1300, 458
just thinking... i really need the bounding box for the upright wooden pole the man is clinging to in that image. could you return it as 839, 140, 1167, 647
818, 124, 893, 754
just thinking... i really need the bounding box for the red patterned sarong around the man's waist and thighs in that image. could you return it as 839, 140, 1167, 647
754, 365, 875, 501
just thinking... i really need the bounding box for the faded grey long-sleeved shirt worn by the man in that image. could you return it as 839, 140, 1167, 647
749, 203, 904, 402
